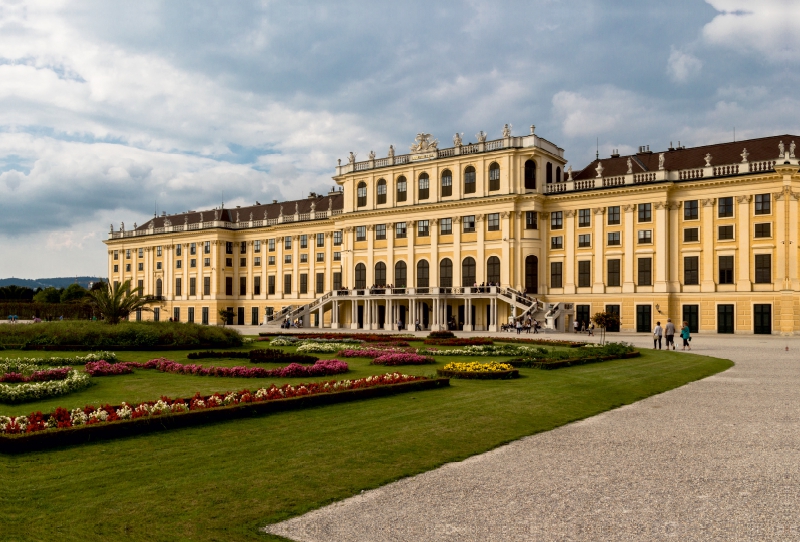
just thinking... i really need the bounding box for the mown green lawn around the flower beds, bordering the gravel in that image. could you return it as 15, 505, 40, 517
0, 343, 731, 540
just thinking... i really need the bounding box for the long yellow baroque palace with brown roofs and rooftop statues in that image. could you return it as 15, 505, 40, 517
104, 125, 800, 334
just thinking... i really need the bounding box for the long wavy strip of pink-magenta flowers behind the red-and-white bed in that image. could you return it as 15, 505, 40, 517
87, 358, 348, 378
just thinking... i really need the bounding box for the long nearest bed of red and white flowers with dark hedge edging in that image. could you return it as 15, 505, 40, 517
0, 373, 449, 453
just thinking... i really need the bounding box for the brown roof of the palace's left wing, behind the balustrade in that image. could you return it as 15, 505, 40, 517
136, 192, 344, 230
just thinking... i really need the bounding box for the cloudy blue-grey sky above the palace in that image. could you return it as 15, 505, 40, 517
0, 0, 800, 278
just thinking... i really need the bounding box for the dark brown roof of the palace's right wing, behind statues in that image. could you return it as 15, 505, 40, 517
572, 134, 800, 181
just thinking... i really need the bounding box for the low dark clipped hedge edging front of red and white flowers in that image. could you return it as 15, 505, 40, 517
0, 378, 450, 454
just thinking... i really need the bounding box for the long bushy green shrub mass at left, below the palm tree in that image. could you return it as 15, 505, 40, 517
0, 321, 242, 350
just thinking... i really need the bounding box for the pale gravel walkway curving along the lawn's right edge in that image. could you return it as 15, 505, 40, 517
265, 335, 800, 542
